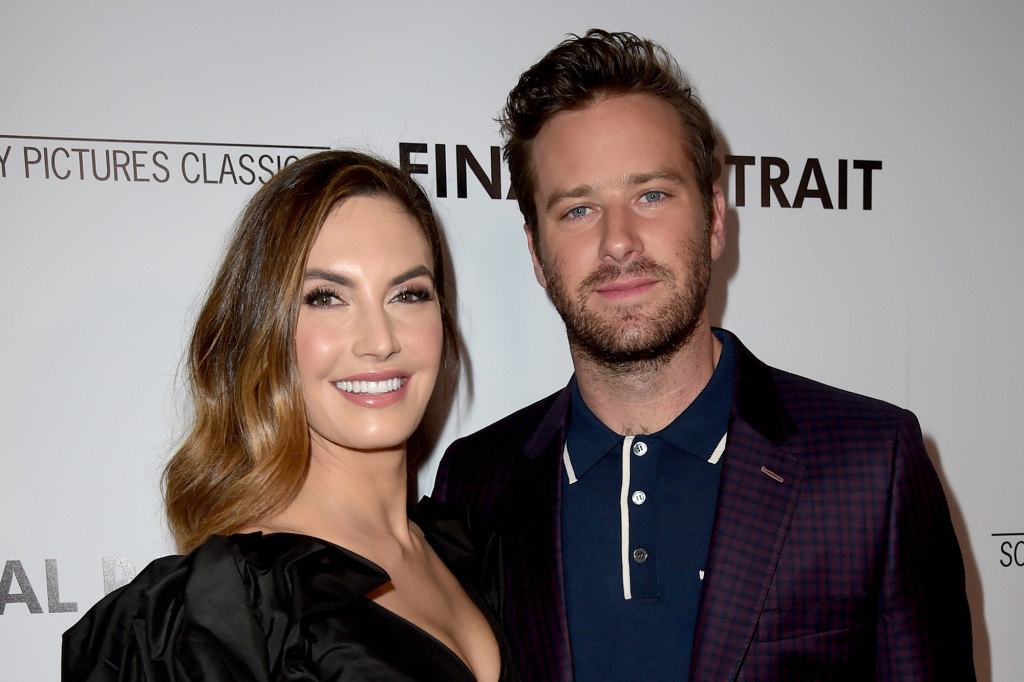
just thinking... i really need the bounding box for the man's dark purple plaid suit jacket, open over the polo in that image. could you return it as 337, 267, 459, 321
434, 327, 975, 682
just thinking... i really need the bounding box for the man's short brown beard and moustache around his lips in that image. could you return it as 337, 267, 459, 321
542, 230, 711, 374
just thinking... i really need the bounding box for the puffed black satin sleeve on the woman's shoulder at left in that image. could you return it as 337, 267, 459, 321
62, 532, 388, 680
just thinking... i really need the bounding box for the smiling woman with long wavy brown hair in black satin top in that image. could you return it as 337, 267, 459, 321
63, 152, 515, 681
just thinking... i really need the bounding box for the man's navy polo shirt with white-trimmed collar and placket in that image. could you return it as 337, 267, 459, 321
561, 327, 735, 682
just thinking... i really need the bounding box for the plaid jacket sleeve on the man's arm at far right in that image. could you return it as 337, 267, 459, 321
877, 411, 976, 682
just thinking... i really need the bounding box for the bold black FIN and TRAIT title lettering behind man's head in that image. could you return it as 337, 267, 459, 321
398, 142, 882, 211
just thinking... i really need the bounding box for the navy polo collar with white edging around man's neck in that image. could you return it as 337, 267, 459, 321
567, 329, 736, 477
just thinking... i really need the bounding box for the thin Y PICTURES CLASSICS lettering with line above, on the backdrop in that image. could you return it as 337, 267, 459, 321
0, 135, 328, 186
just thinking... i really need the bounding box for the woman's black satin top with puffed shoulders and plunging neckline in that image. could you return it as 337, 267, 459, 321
61, 498, 519, 682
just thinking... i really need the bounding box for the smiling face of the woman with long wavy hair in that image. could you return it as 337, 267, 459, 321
295, 197, 442, 451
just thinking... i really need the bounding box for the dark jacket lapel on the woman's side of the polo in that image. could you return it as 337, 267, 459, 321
502, 388, 572, 681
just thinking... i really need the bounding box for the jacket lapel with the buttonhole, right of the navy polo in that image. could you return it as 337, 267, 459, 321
690, 337, 804, 682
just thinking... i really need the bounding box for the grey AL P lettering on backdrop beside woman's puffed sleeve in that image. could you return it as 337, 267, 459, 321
0, 556, 135, 615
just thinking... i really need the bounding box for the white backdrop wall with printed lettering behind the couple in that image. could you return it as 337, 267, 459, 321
0, 0, 1024, 682
